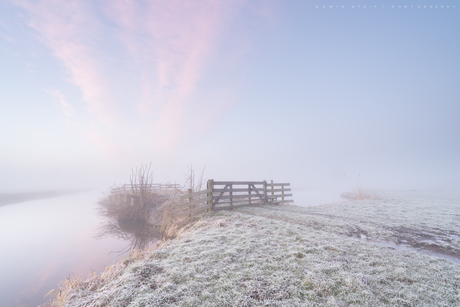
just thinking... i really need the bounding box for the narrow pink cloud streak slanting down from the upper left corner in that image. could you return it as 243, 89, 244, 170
15, 0, 118, 123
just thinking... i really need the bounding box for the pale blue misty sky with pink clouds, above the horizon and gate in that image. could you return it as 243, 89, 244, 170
0, 0, 460, 195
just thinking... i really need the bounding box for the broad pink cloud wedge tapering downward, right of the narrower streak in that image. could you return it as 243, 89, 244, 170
99, 0, 240, 145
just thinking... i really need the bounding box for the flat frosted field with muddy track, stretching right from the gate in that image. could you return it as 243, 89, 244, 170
241, 191, 460, 258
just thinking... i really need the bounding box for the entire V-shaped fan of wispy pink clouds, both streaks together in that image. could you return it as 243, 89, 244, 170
14, 0, 274, 153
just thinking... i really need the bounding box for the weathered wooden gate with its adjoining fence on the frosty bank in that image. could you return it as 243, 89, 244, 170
176, 180, 293, 224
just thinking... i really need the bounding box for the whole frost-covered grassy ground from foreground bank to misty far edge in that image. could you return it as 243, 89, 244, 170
49, 193, 460, 306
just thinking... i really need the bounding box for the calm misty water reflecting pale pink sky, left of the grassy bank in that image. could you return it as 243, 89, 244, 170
0, 192, 146, 307
